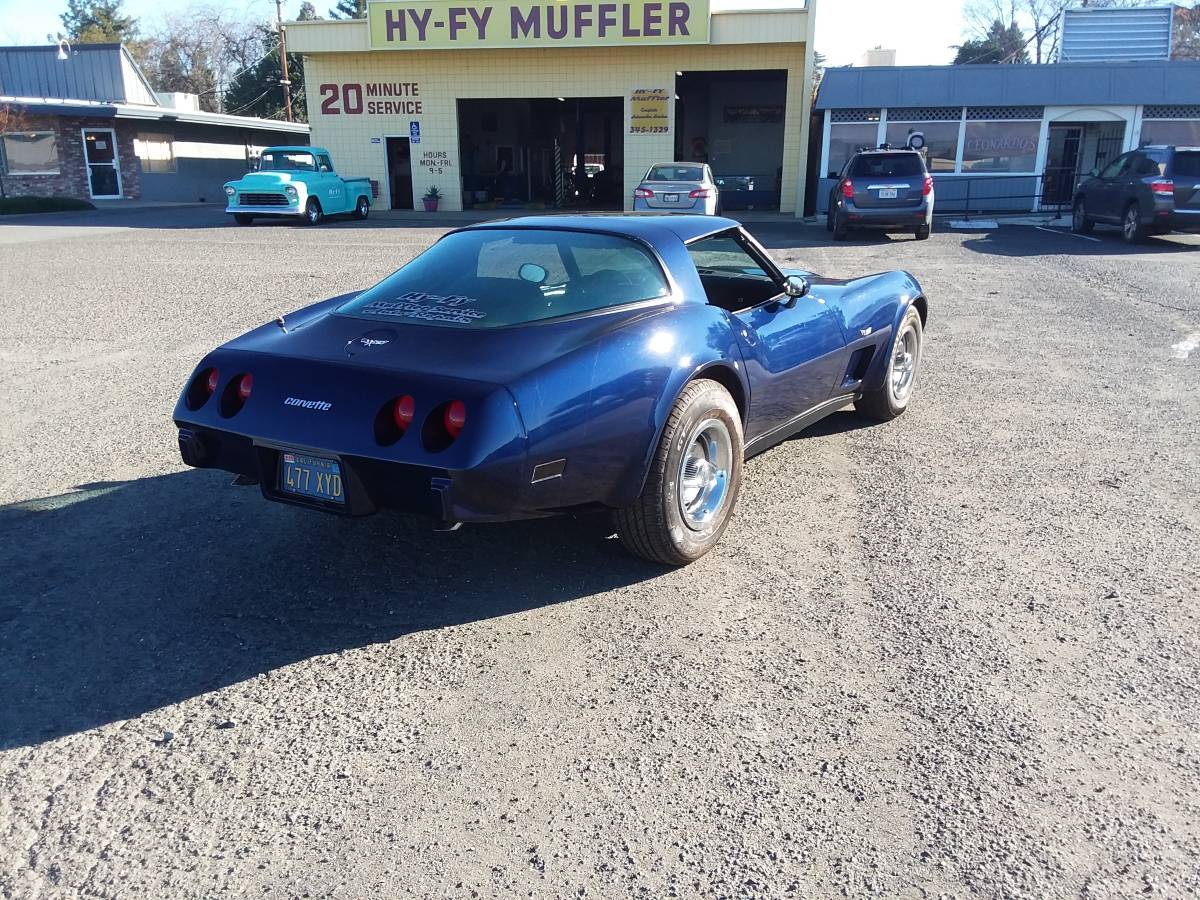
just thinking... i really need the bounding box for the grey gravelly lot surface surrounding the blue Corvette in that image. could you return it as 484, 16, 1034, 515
0, 210, 1200, 899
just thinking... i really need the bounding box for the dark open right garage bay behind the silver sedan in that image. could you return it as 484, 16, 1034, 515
674, 70, 787, 210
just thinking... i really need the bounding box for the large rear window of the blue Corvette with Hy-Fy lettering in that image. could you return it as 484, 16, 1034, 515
338, 228, 671, 328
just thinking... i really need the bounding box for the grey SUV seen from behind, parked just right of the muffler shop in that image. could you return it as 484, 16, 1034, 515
826, 149, 934, 241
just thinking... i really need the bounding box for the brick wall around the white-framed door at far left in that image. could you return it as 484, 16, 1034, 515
0, 115, 140, 200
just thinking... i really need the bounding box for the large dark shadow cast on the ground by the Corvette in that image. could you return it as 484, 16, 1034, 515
0, 470, 664, 748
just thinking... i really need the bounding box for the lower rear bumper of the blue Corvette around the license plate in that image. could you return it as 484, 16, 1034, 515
176, 422, 532, 523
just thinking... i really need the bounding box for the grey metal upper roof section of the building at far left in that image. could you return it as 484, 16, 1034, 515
0, 43, 158, 106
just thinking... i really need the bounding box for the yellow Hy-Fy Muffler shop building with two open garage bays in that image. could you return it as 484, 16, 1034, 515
288, 0, 814, 212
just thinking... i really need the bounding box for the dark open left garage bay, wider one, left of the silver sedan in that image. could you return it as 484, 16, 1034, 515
458, 97, 624, 210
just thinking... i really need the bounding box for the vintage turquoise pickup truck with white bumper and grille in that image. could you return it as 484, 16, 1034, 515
224, 146, 371, 224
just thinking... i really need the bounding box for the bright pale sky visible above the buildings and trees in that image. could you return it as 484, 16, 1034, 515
0, 0, 962, 66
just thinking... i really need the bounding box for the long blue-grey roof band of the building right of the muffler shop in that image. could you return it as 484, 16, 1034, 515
814, 60, 1200, 109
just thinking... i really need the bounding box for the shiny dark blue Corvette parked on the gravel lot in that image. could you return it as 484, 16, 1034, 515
174, 216, 928, 565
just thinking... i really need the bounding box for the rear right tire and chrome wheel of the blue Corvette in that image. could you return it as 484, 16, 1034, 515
613, 378, 745, 565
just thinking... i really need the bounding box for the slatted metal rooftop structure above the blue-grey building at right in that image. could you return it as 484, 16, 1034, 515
1058, 6, 1175, 62
